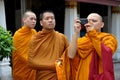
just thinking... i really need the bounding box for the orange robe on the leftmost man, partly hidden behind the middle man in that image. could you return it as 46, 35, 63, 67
12, 26, 36, 80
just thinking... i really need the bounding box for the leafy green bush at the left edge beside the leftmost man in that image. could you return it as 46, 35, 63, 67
0, 26, 14, 61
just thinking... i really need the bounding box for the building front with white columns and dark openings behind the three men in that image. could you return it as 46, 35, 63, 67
0, 0, 120, 59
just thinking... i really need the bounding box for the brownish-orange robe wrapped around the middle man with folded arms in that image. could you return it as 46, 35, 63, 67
28, 29, 68, 80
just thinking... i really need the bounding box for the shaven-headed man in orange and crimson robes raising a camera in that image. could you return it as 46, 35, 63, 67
56, 13, 118, 80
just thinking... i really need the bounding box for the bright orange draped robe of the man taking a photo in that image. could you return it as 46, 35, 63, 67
56, 30, 118, 80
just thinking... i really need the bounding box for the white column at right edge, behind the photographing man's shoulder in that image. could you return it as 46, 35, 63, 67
111, 6, 120, 60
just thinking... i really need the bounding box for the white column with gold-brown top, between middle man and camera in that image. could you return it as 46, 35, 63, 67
64, 1, 77, 41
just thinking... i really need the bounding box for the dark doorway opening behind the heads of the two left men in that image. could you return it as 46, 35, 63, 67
26, 0, 65, 33
